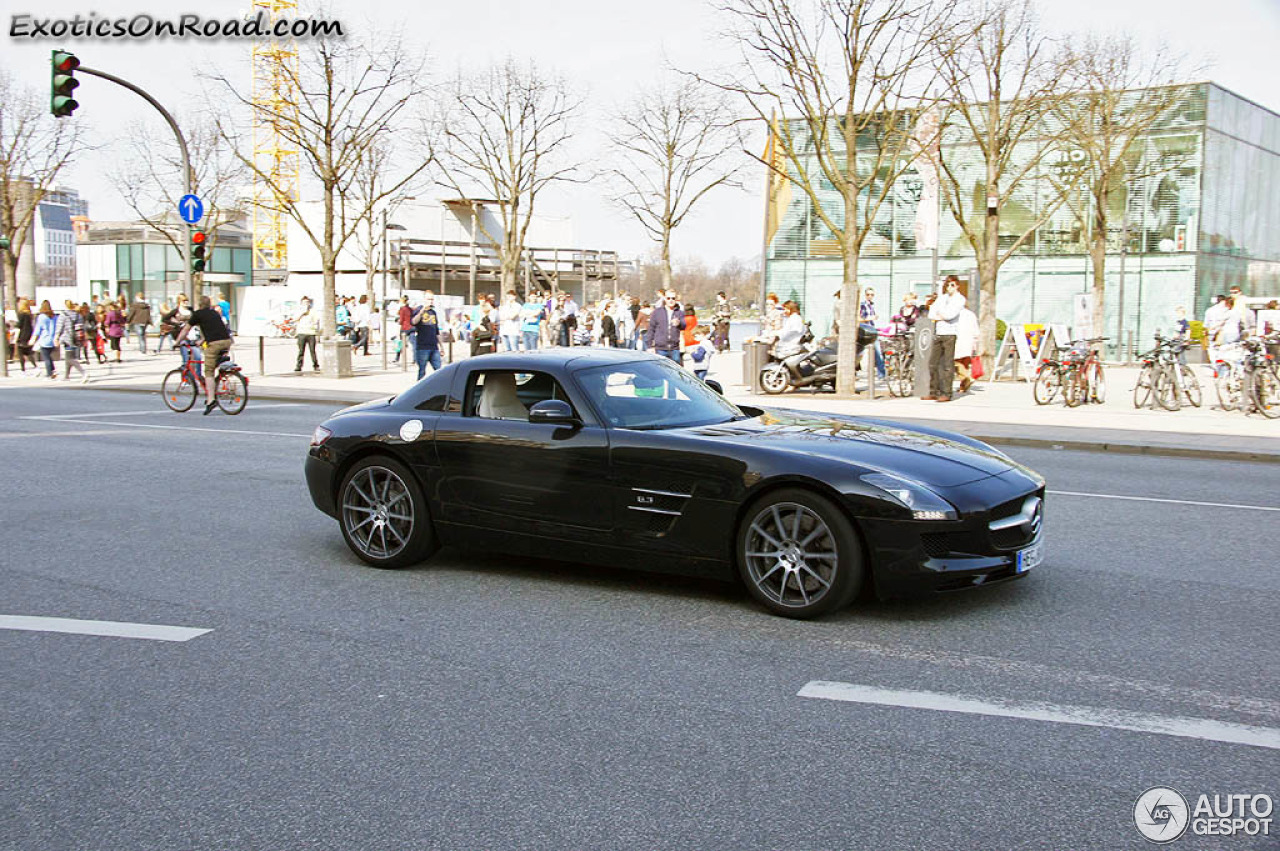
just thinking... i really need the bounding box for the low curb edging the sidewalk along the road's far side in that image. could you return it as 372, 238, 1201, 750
5, 383, 1280, 463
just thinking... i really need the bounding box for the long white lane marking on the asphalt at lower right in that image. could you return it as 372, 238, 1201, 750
797, 680, 1280, 750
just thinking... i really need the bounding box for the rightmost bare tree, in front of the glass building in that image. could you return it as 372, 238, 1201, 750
1059, 36, 1187, 339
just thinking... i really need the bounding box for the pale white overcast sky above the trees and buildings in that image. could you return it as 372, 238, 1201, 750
0, 0, 1280, 267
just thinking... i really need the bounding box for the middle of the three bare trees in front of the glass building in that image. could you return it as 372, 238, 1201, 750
933, 0, 1071, 352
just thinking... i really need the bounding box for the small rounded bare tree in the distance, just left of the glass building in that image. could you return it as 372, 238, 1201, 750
609, 79, 742, 288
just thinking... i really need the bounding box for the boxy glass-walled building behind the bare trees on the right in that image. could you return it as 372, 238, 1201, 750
765, 83, 1280, 344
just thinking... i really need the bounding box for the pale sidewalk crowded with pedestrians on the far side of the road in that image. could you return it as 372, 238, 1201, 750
0, 338, 1280, 462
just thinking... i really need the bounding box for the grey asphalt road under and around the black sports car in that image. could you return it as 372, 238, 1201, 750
0, 389, 1280, 851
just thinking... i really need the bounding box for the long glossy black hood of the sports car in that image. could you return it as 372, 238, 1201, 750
689, 408, 1015, 488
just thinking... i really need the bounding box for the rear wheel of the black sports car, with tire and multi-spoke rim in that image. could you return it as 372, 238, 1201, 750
338, 456, 439, 568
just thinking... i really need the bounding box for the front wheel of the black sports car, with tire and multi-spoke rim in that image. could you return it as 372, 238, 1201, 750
737, 488, 864, 618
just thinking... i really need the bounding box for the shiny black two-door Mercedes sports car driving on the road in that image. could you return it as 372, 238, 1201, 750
306, 348, 1044, 617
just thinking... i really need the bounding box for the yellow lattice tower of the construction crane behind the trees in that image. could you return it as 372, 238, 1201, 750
253, 0, 298, 269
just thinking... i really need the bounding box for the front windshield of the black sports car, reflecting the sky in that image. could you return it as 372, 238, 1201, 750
573, 358, 745, 429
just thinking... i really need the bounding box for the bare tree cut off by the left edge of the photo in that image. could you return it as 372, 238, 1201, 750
0, 70, 83, 305
